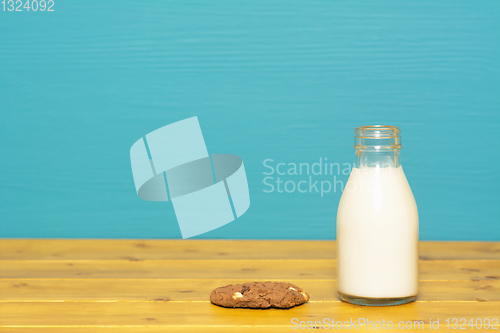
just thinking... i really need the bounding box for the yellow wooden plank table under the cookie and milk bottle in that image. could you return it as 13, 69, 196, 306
0, 239, 500, 333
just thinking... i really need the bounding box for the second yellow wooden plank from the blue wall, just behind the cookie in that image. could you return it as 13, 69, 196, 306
0, 260, 500, 280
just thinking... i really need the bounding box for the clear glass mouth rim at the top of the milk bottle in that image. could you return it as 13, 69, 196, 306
354, 125, 402, 151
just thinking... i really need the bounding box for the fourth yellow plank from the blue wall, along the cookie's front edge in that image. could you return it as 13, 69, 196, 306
0, 302, 500, 326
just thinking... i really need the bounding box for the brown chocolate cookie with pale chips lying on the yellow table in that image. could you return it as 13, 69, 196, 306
210, 281, 309, 309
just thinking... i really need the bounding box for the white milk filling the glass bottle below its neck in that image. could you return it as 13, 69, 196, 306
337, 166, 418, 298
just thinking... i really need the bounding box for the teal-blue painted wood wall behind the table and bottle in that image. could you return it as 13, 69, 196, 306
0, 0, 500, 240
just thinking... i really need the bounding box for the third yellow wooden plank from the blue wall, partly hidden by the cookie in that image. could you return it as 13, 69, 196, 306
0, 279, 500, 302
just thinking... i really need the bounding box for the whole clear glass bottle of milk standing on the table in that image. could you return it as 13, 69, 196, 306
337, 125, 418, 306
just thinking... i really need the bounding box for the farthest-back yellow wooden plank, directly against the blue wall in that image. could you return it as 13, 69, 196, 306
0, 239, 500, 260
